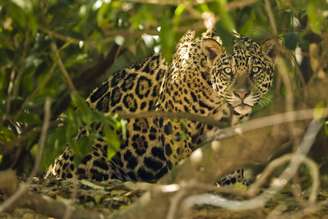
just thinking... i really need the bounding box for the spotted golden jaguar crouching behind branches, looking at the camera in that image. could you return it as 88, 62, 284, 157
46, 28, 274, 184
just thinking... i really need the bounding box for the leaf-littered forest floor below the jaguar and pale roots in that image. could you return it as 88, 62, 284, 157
0, 178, 328, 219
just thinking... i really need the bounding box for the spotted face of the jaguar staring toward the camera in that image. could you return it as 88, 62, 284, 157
204, 37, 274, 115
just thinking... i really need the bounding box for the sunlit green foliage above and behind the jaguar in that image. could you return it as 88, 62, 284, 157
0, 0, 328, 175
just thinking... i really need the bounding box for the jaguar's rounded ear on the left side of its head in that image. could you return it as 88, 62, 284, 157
201, 38, 225, 63
